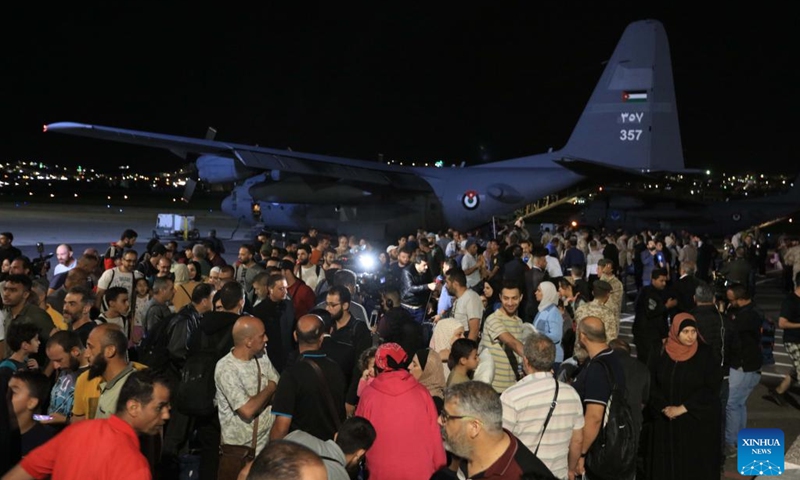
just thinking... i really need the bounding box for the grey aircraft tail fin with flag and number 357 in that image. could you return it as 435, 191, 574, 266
561, 20, 685, 171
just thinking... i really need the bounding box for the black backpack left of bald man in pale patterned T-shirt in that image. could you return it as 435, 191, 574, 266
173, 330, 232, 416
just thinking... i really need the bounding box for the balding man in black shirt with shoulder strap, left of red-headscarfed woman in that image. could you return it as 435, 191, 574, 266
269, 314, 346, 440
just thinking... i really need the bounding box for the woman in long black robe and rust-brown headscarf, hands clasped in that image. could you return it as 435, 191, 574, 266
647, 313, 721, 480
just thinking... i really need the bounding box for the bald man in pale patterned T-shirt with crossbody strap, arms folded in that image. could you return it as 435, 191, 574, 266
214, 316, 280, 454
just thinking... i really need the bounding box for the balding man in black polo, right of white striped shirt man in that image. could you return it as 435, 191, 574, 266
573, 316, 632, 478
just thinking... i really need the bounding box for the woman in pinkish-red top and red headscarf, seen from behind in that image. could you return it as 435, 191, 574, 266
356, 343, 445, 480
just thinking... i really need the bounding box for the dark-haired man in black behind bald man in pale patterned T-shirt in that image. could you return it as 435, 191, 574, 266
252, 272, 295, 372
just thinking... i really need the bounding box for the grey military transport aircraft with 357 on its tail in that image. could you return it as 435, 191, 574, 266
44, 20, 685, 237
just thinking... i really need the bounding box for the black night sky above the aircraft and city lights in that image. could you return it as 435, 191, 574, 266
0, 2, 800, 171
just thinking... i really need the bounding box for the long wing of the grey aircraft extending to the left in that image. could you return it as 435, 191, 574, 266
44, 122, 431, 191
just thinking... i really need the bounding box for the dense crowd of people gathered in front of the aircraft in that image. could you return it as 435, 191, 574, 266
0, 224, 800, 480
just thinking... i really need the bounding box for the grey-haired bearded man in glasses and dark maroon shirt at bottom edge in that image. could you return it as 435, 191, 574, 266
438, 382, 556, 479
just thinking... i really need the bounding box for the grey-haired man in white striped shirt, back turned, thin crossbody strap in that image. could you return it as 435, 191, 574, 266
500, 333, 584, 479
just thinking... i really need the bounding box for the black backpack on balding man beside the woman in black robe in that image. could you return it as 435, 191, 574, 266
586, 360, 639, 479
